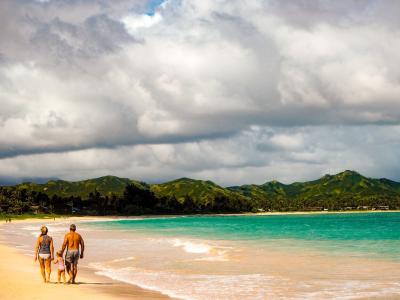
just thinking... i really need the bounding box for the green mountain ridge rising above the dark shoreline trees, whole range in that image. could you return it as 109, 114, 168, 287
1, 170, 400, 211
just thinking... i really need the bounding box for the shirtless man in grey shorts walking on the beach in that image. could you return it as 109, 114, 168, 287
61, 224, 85, 283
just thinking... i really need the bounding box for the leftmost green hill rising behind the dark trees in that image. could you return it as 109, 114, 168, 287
16, 176, 146, 198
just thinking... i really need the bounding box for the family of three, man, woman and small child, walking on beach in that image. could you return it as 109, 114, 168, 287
35, 224, 85, 283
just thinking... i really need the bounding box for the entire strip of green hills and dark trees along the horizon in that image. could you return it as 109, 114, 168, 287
0, 171, 400, 215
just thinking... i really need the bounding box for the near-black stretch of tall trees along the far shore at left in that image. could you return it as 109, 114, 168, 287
0, 184, 252, 215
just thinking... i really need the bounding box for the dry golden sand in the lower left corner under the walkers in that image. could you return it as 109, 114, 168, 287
0, 220, 171, 300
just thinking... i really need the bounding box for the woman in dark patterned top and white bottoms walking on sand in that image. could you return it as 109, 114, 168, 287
35, 226, 54, 283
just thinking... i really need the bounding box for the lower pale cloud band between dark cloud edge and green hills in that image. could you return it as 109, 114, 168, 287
0, 126, 400, 186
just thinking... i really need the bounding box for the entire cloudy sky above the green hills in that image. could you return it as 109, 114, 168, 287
0, 0, 400, 186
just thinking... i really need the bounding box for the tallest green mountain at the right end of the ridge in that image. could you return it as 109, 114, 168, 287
228, 170, 400, 209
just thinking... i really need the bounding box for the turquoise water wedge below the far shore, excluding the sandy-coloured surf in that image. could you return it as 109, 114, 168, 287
93, 212, 400, 260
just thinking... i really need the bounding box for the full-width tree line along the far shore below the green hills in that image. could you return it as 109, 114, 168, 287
0, 184, 400, 215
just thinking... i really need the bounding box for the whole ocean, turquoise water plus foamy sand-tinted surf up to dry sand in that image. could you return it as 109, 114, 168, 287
4, 212, 400, 299
